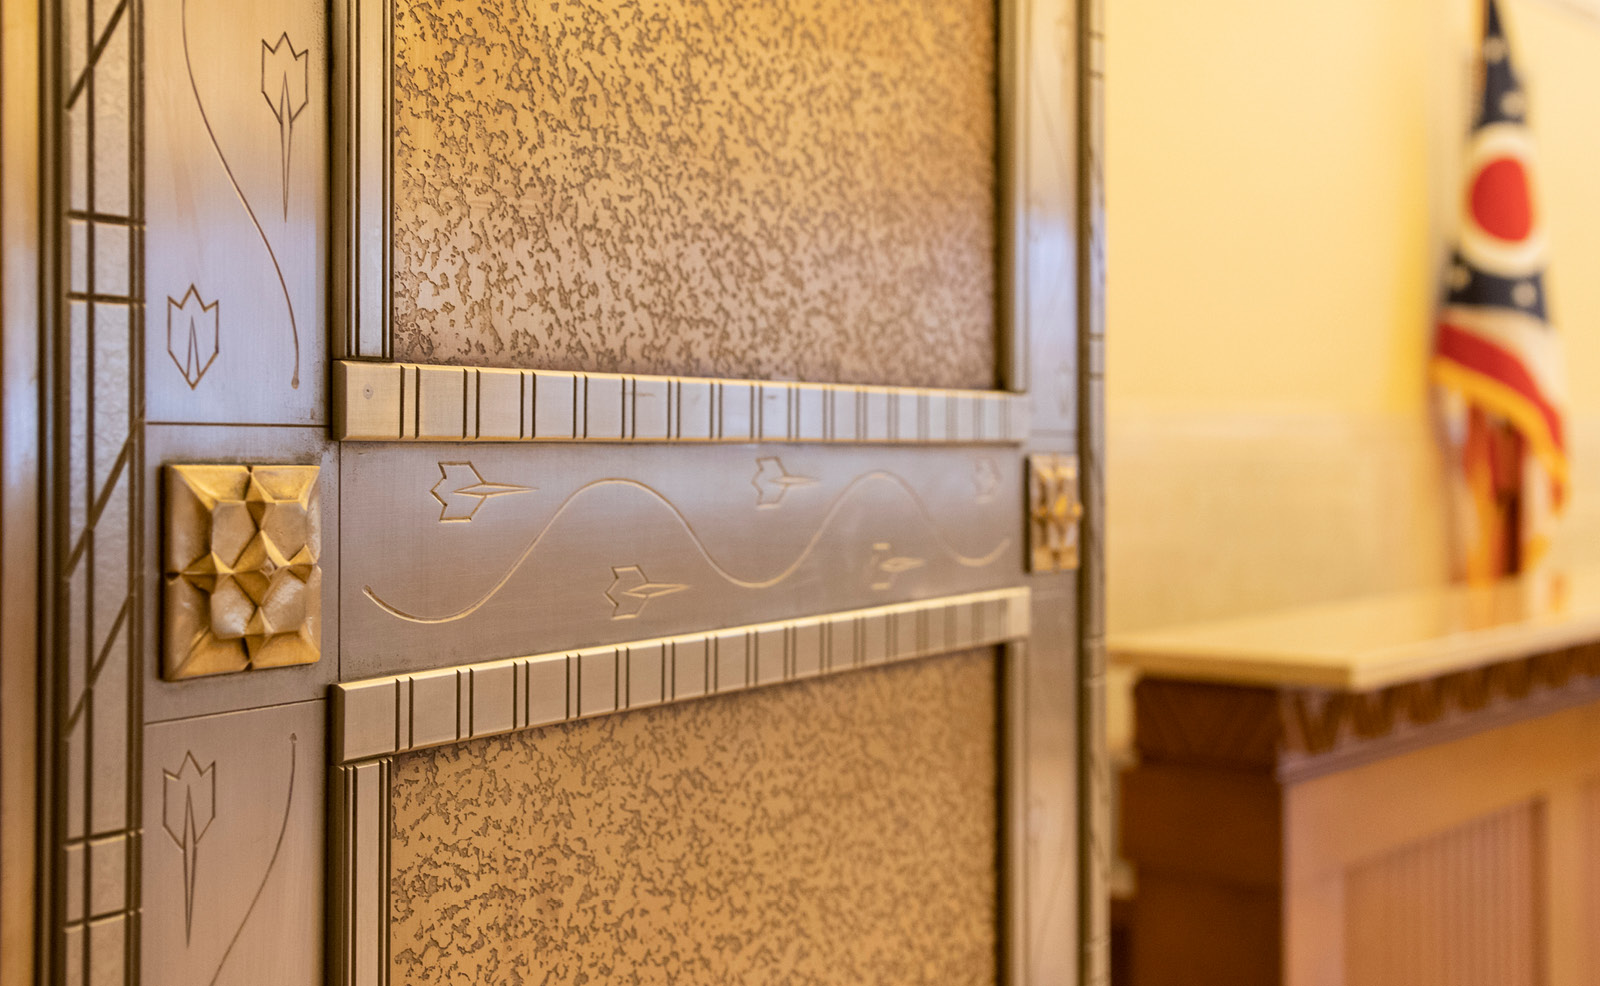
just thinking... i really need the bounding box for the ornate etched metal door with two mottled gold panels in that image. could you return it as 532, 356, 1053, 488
5, 0, 1104, 986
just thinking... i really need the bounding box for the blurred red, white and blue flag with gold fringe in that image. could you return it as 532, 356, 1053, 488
1432, 0, 1568, 581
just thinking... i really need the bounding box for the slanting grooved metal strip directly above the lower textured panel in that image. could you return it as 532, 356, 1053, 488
333, 587, 1030, 764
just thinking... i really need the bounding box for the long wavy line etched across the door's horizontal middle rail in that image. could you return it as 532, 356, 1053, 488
362, 471, 1011, 624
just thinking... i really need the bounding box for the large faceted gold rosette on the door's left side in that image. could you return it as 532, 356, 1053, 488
162, 466, 322, 680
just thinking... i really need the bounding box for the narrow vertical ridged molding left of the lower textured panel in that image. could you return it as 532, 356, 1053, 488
328, 757, 390, 986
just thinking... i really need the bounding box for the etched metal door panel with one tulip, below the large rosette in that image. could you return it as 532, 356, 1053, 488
141, 701, 325, 986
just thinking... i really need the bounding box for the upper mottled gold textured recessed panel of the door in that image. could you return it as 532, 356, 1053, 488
392, 0, 997, 387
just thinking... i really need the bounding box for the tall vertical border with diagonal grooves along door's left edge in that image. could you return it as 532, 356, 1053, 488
44, 0, 144, 984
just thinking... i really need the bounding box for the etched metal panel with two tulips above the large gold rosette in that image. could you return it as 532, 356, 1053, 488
145, 0, 328, 424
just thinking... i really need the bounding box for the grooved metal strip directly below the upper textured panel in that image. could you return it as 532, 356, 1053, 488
333, 362, 1029, 445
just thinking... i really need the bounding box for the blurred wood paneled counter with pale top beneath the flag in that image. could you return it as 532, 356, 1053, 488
1110, 570, 1600, 986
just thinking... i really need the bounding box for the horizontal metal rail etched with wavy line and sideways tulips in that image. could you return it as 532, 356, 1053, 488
339, 443, 1022, 680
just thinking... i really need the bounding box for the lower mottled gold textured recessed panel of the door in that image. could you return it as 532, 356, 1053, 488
389, 650, 998, 986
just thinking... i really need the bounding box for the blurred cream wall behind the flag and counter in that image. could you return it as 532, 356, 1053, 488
1106, 0, 1600, 741
